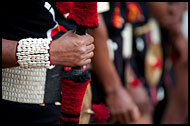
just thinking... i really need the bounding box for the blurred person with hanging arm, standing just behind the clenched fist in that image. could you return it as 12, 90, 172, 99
89, 2, 140, 123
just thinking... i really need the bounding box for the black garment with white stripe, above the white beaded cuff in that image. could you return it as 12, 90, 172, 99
2, 1, 71, 41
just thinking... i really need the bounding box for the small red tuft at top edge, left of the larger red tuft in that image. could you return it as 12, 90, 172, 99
56, 2, 73, 14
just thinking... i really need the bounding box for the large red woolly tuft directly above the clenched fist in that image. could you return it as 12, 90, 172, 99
67, 2, 98, 28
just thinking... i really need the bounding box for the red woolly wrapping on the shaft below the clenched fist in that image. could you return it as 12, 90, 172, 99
60, 78, 90, 122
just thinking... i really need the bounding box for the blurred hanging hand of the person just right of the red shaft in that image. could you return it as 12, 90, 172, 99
106, 87, 140, 123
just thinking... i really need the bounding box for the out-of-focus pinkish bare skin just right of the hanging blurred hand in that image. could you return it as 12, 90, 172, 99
125, 64, 153, 124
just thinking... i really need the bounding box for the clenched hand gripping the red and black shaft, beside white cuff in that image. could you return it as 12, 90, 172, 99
50, 31, 95, 66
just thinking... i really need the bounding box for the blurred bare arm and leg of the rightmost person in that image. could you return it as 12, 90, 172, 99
149, 2, 188, 124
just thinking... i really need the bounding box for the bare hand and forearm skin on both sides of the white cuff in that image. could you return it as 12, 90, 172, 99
2, 31, 95, 68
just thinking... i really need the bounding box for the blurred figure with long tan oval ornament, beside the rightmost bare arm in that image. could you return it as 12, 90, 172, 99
126, 2, 164, 124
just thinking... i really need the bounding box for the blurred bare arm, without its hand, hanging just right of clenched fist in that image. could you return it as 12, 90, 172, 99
89, 15, 121, 93
